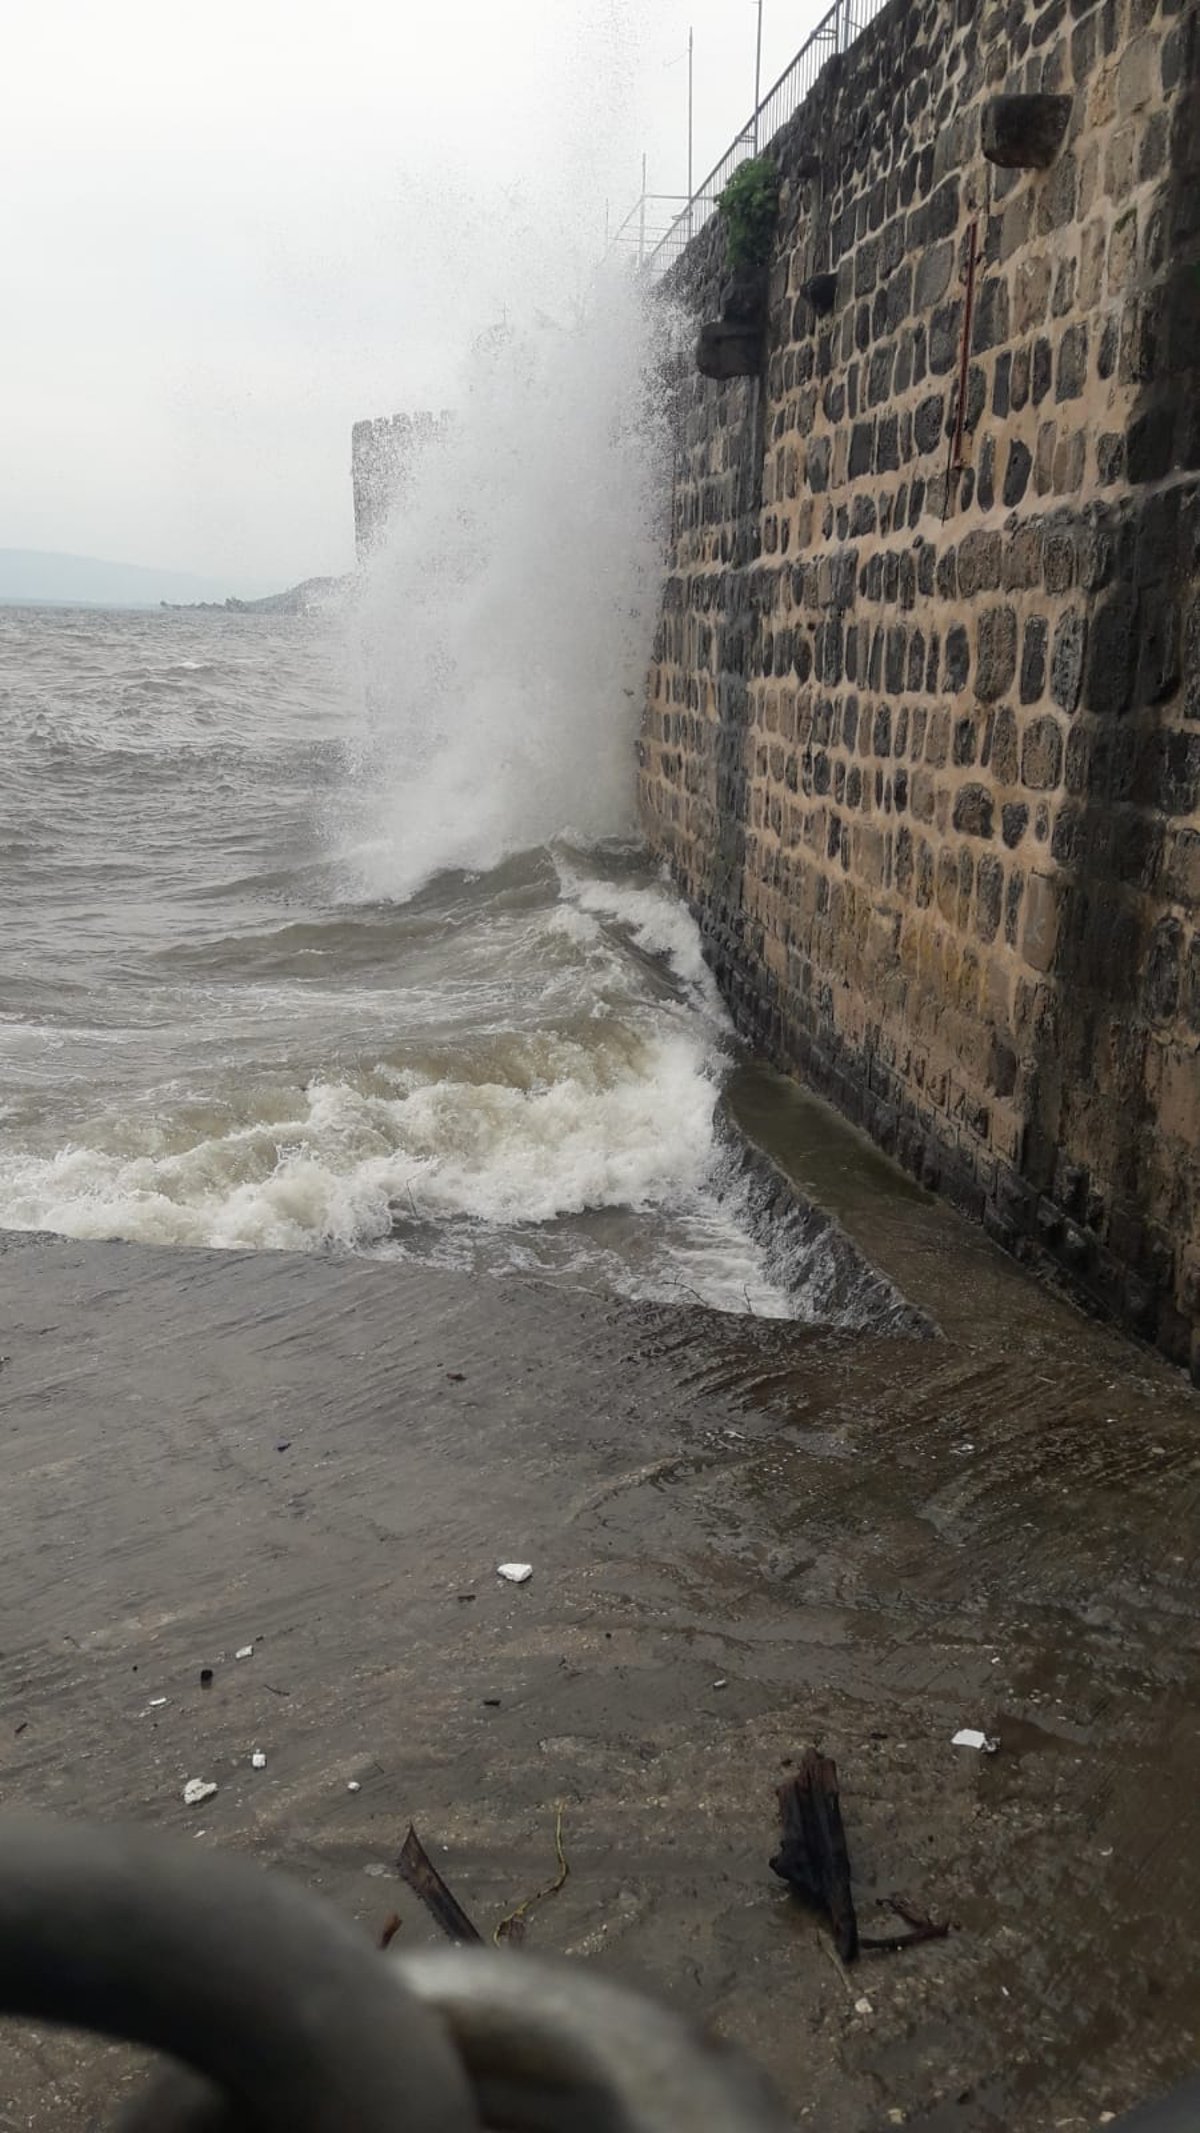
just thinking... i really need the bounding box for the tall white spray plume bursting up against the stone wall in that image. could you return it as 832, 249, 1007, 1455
339, 271, 671, 898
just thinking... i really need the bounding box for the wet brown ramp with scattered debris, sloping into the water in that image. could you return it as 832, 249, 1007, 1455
0, 1079, 1200, 2133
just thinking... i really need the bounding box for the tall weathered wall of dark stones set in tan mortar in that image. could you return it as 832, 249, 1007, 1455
642, 0, 1200, 1378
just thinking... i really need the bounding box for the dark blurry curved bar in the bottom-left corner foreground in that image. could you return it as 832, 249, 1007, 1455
0, 1817, 477, 2133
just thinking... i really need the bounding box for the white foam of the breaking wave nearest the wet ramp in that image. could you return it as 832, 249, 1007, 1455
4, 1026, 714, 1248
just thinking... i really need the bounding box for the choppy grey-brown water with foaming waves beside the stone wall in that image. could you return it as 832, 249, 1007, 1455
0, 610, 793, 1314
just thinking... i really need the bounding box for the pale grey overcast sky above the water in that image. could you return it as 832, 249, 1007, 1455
0, 0, 823, 591
